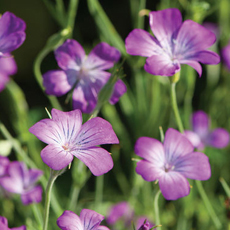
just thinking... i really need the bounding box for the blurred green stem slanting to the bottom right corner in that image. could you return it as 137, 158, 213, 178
196, 180, 222, 229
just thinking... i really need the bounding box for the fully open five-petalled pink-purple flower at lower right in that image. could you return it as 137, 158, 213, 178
135, 128, 211, 200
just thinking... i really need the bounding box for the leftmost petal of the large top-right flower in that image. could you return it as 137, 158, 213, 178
125, 29, 162, 57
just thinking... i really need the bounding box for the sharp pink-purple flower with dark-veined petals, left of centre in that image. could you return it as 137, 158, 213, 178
29, 109, 119, 176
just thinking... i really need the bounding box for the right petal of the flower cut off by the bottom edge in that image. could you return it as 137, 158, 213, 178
80, 209, 104, 230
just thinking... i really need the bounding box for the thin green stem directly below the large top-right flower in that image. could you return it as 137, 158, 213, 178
170, 82, 184, 133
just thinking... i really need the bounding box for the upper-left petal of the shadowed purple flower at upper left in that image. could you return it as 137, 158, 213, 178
54, 39, 85, 70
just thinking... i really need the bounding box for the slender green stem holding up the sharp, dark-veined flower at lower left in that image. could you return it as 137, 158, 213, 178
43, 169, 58, 230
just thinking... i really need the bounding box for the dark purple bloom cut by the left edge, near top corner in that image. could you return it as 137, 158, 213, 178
0, 12, 26, 56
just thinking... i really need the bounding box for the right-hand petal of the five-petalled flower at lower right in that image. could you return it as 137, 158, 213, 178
174, 152, 211, 180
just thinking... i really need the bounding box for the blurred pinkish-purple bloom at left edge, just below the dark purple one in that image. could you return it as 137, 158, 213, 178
0, 55, 17, 92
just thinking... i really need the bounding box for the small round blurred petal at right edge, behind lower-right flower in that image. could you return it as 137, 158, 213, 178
208, 128, 229, 149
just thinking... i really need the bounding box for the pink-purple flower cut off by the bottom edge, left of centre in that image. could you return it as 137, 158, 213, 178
57, 209, 109, 230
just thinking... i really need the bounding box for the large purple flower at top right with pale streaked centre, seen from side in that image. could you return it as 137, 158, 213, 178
125, 9, 220, 76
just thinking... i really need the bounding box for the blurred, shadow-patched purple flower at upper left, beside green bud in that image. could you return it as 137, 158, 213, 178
43, 39, 120, 113
